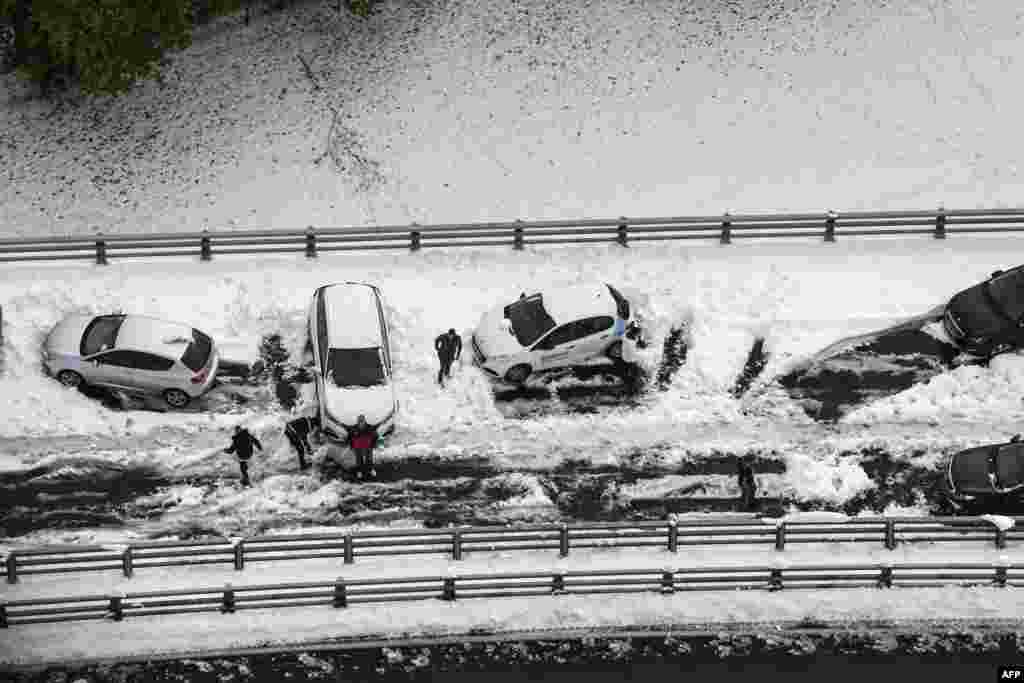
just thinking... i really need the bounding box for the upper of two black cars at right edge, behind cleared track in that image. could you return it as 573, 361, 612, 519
942, 265, 1024, 358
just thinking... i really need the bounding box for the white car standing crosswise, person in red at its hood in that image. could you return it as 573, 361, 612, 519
309, 283, 398, 440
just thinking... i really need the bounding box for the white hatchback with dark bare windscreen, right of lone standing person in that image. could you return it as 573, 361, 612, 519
470, 284, 640, 384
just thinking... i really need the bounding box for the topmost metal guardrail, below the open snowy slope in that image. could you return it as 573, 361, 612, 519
0, 209, 1024, 265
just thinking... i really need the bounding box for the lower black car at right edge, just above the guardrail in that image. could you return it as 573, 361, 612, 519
946, 434, 1024, 509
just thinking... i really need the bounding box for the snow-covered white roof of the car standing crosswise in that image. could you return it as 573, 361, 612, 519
321, 283, 384, 348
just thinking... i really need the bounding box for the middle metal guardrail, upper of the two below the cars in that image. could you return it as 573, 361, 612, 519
3, 517, 1024, 584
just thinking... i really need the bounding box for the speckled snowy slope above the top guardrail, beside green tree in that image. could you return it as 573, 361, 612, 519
0, 0, 1024, 234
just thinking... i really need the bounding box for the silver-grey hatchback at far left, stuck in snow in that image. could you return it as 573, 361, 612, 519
42, 313, 219, 408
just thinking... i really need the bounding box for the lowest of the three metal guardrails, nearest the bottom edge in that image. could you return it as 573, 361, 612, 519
0, 563, 1024, 628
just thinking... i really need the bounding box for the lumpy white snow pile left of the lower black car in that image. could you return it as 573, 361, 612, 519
782, 452, 874, 504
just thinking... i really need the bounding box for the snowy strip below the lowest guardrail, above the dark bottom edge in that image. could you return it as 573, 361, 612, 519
0, 586, 1024, 665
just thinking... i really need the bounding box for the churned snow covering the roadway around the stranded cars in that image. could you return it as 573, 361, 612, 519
0, 237, 1024, 541
